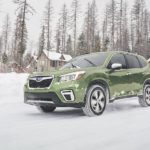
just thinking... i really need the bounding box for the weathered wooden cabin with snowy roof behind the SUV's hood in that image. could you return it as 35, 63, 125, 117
36, 50, 72, 72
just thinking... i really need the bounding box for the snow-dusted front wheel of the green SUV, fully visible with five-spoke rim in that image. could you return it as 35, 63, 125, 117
82, 85, 107, 117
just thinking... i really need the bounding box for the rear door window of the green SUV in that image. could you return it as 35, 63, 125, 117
126, 55, 141, 69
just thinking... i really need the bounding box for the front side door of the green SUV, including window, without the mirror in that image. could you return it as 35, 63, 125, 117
108, 54, 130, 99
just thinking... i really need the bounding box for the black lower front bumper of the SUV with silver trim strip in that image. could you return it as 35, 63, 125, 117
24, 92, 85, 108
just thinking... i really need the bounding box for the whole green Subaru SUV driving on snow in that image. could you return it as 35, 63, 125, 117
24, 51, 150, 116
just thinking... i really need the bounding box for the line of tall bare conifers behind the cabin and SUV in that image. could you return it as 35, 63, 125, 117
0, 0, 150, 66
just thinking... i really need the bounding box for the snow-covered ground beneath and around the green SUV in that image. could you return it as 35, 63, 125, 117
0, 73, 150, 150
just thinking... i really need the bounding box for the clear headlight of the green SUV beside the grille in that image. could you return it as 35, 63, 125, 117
60, 71, 85, 82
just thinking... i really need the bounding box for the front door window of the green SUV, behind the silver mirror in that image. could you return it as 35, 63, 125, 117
108, 54, 127, 69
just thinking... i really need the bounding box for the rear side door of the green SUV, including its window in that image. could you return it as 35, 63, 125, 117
125, 54, 143, 95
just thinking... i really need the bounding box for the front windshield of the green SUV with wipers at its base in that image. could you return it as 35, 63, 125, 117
61, 52, 107, 69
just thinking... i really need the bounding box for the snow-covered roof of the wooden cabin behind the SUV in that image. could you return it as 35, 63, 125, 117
43, 50, 72, 61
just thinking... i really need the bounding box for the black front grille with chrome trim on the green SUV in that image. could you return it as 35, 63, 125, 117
29, 76, 53, 88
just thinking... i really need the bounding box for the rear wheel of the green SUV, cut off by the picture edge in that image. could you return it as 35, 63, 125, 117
139, 85, 150, 107
